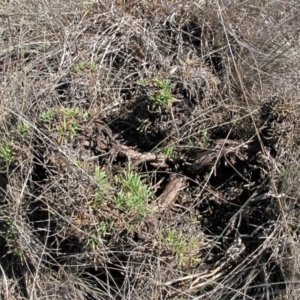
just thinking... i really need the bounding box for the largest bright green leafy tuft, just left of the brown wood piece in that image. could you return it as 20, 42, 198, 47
115, 166, 153, 216
